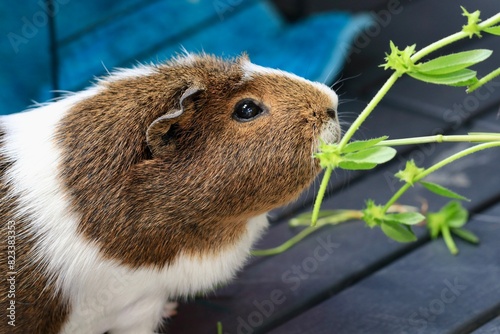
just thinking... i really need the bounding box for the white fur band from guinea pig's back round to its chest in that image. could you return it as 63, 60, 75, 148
0, 88, 267, 334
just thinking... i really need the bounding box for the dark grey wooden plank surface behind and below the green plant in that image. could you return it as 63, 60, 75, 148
167, 0, 500, 334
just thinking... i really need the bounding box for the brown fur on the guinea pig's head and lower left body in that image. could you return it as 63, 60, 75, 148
0, 56, 338, 333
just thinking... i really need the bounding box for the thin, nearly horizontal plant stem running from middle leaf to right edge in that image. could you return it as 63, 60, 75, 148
376, 133, 500, 146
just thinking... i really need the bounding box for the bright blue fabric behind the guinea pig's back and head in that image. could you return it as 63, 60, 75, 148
0, 0, 369, 114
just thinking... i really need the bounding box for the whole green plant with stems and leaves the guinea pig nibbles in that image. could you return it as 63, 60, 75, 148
254, 7, 500, 255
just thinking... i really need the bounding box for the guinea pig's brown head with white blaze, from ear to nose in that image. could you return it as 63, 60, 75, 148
147, 57, 340, 216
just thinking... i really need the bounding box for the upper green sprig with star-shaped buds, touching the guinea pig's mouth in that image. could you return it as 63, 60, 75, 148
312, 7, 500, 220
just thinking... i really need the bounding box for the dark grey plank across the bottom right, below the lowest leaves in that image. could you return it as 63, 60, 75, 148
270, 205, 500, 334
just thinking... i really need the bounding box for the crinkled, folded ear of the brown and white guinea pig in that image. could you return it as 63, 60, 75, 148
146, 87, 203, 157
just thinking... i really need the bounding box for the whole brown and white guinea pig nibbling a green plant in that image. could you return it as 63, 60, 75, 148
0, 54, 340, 334
